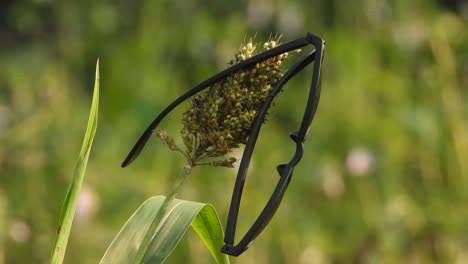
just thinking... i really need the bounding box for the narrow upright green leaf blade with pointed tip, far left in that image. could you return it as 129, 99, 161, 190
50, 60, 99, 264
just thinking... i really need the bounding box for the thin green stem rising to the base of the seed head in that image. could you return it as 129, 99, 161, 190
133, 164, 192, 264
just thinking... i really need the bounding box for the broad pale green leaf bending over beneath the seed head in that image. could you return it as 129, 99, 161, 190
100, 196, 229, 264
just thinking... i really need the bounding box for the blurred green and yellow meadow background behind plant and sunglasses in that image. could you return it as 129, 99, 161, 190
0, 0, 468, 263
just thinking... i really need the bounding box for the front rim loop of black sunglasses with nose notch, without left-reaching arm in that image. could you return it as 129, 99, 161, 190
221, 33, 324, 256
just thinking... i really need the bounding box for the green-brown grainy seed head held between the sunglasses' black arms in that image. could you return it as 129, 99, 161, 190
181, 39, 288, 167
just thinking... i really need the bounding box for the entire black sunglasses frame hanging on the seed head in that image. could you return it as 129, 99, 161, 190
122, 33, 325, 256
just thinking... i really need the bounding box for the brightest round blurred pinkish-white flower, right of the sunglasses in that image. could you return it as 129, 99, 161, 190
346, 147, 375, 177
